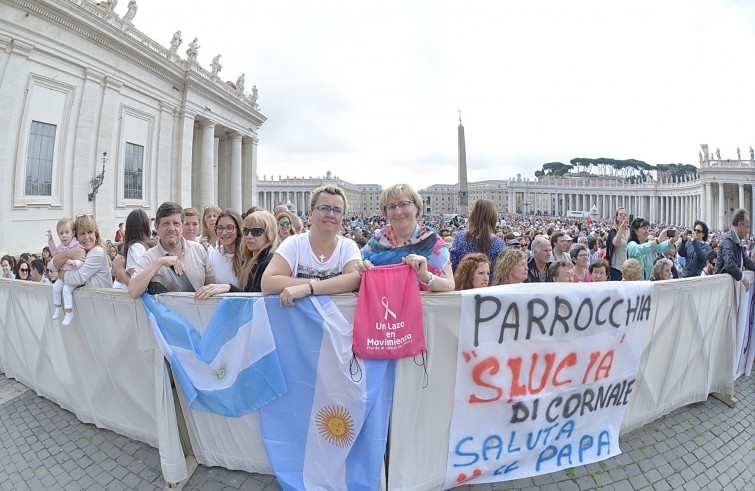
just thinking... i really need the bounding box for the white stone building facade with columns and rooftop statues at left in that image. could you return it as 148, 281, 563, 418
0, 0, 266, 252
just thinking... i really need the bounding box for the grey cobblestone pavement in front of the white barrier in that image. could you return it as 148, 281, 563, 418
0, 375, 755, 491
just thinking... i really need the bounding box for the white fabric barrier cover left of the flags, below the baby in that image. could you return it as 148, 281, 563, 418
0, 279, 188, 482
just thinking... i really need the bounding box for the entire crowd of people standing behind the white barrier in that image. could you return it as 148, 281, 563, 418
1, 184, 755, 325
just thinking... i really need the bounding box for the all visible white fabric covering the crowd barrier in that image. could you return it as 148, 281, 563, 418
0, 275, 752, 490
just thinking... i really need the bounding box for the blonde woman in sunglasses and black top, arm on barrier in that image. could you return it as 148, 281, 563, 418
194, 210, 278, 300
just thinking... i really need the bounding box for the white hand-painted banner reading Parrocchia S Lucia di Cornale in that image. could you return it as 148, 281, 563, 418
444, 281, 653, 489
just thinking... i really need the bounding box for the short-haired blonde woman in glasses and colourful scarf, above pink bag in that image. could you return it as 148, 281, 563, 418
358, 184, 455, 292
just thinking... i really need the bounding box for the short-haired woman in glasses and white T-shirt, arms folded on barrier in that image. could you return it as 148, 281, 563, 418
262, 184, 361, 307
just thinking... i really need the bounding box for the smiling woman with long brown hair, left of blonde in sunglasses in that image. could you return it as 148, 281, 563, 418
208, 210, 244, 287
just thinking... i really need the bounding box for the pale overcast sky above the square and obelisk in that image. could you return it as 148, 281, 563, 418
131, 0, 755, 189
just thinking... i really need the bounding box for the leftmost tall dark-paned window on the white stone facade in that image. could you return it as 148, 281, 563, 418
24, 121, 58, 196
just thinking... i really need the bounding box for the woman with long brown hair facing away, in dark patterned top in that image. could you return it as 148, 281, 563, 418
451, 199, 506, 279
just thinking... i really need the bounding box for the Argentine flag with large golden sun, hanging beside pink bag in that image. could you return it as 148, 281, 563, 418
260, 295, 396, 491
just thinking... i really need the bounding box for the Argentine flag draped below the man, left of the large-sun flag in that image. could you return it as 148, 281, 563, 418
142, 294, 286, 418
